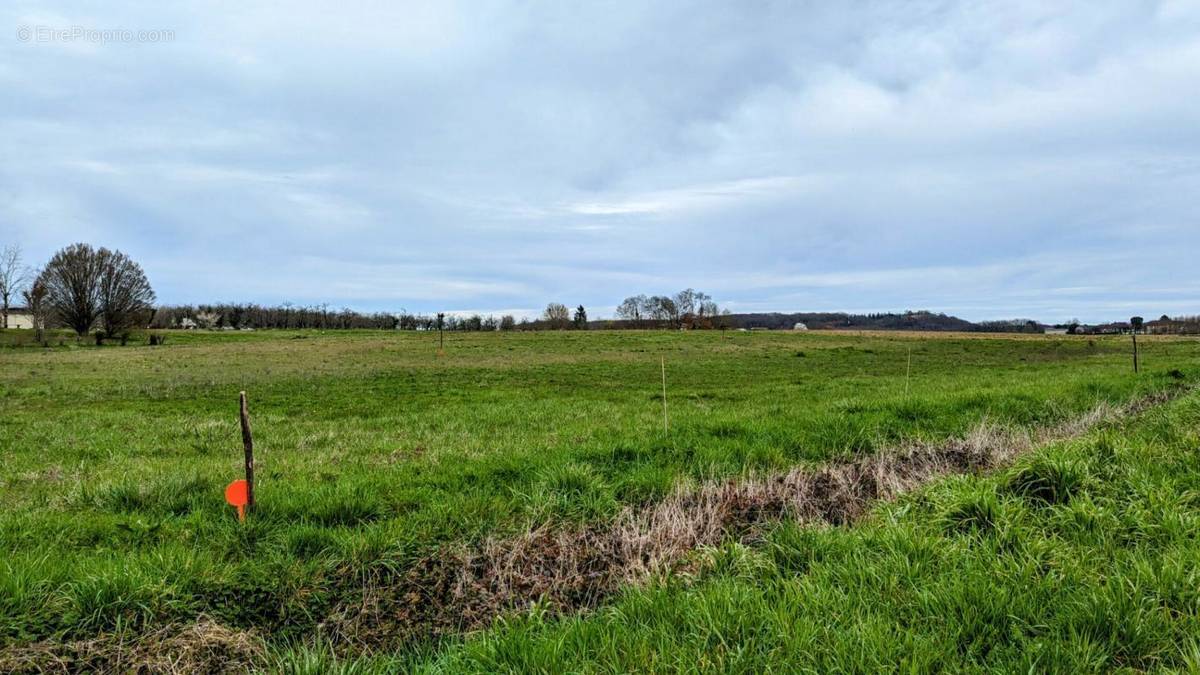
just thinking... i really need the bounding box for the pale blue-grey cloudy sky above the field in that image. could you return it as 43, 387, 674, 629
0, 0, 1200, 322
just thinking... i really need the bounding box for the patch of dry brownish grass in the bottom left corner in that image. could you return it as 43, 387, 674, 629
0, 617, 264, 675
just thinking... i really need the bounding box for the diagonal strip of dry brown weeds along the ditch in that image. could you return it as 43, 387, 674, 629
322, 389, 1183, 650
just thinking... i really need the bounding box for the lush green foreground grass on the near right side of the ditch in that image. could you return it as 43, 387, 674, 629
415, 395, 1200, 673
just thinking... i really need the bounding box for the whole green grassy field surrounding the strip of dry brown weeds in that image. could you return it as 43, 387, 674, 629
0, 331, 1200, 673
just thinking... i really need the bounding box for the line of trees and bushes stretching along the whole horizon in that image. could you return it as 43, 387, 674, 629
14, 244, 1185, 336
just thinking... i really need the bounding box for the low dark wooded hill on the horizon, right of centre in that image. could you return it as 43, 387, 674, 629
728, 311, 1042, 333
